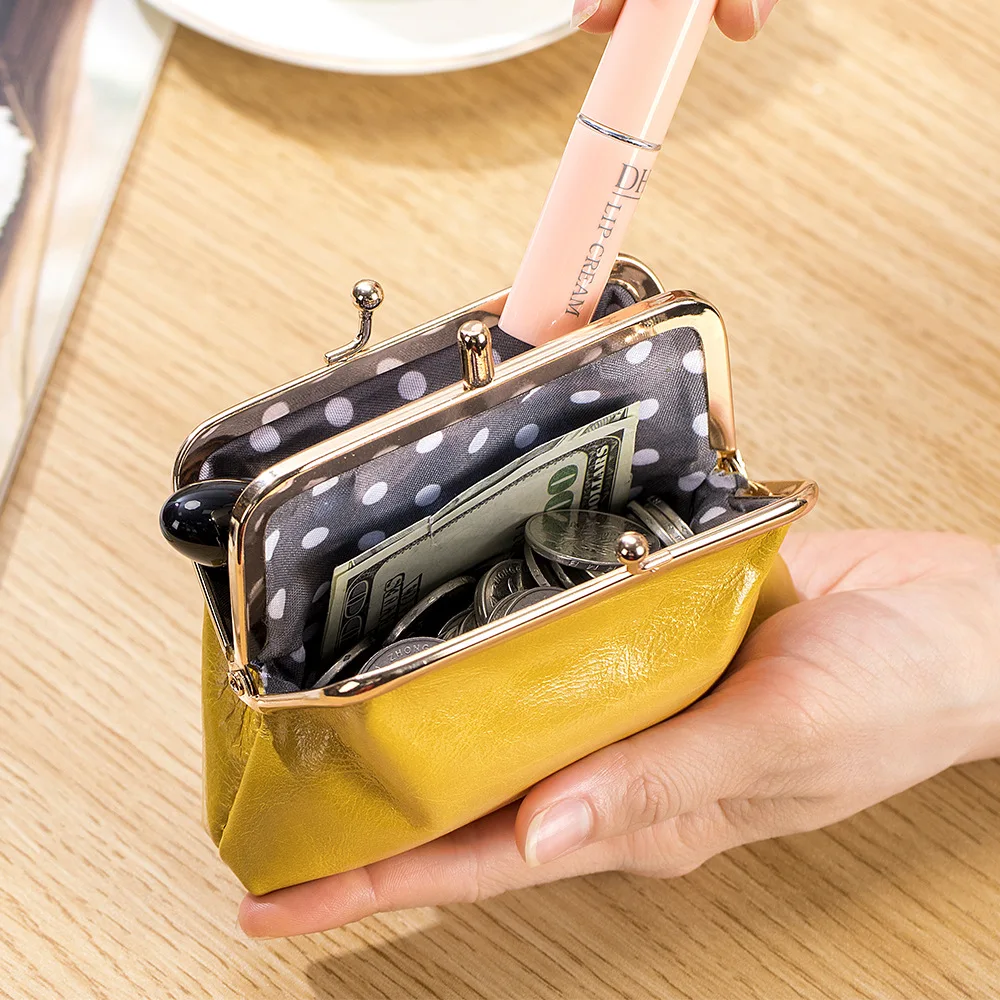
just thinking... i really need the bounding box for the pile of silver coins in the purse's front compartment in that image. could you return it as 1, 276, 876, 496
315, 497, 692, 687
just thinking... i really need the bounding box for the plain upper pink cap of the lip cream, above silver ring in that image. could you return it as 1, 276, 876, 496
582, 0, 717, 145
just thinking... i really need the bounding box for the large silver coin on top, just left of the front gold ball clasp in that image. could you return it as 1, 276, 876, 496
524, 510, 652, 571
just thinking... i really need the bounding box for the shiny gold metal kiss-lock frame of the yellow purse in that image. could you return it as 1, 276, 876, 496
174, 256, 817, 712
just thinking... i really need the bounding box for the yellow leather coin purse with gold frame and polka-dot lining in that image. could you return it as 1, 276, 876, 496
163, 257, 816, 894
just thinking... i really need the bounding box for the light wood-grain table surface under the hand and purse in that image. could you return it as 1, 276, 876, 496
0, 0, 1000, 1000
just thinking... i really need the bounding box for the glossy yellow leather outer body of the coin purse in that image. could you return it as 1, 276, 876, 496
204, 529, 794, 894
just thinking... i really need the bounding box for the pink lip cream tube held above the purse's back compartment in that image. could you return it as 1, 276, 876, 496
500, 0, 717, 345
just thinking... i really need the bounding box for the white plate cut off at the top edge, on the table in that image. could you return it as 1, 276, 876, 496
149, 0, 573, 74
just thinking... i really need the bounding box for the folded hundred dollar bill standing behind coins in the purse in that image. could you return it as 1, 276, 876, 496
323, 404, 639, 658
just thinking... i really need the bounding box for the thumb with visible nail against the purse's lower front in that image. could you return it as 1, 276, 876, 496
515, 677, 771, 865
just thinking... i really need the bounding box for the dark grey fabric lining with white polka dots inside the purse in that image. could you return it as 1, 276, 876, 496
201, 292, 762, 694
